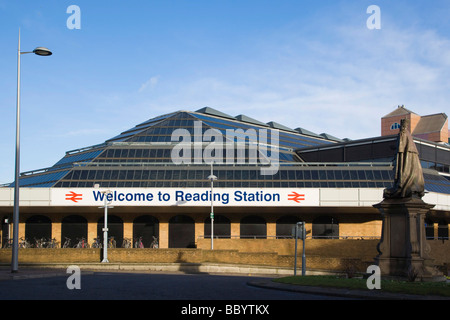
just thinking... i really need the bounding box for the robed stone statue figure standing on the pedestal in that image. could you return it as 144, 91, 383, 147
383, 119, 425, 199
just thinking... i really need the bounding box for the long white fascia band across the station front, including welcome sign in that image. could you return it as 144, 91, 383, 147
0, 188, 450, 212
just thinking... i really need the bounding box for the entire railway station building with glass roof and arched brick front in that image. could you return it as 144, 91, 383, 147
0, 106, 450, 248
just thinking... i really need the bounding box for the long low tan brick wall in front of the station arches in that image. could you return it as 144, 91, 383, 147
0, 239, 450, 272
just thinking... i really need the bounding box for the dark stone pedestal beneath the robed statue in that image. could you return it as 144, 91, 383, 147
374, 198, 445, 281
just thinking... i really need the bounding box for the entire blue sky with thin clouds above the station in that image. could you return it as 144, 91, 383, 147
0, 0, 450, 184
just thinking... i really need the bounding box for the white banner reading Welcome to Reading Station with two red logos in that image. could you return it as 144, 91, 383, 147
51, 188, 319, 207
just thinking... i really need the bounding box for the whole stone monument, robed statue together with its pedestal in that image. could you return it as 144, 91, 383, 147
374, 119, 445, 281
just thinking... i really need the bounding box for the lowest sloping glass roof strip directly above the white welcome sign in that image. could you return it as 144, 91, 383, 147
56, 163, 393, 188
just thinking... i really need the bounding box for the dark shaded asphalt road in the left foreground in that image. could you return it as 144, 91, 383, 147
0, 272, 350, 301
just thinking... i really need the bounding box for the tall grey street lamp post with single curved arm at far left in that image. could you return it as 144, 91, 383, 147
11, 29, 52, 273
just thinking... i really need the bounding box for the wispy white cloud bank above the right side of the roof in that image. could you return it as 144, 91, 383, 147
129, 20, 450, 139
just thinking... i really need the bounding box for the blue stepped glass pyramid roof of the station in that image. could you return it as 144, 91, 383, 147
5, 108, 450, 194
